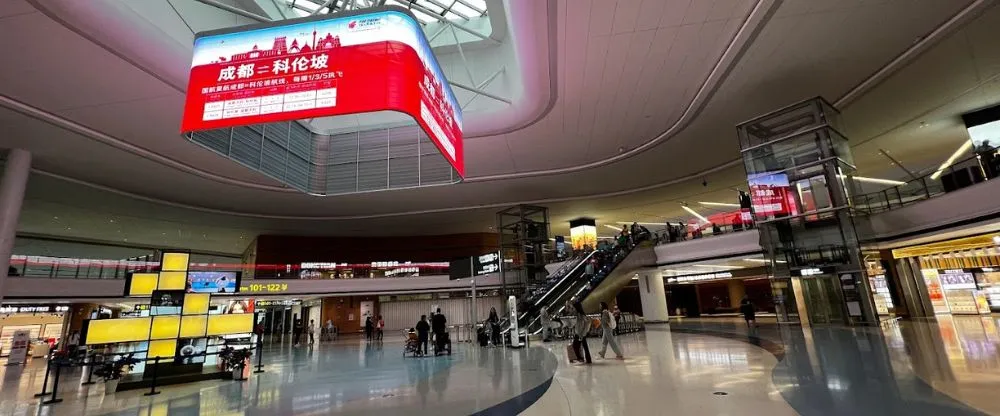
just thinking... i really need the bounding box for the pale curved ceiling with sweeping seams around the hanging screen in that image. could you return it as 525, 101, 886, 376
0, 0, 1000, 252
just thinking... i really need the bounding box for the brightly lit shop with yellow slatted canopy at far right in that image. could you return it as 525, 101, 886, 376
892, 234, 1000, 315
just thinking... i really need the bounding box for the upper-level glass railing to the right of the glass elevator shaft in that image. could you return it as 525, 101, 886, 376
851, 149, 996, 215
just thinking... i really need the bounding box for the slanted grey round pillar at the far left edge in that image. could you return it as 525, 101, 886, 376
0, 149, 31, 301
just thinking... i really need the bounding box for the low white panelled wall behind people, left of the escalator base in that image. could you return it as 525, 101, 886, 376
379, 296, 505, 331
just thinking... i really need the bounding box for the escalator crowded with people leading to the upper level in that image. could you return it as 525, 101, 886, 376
518, 234, 656, 333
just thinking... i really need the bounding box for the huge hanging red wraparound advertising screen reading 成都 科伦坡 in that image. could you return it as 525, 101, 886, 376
181, 6, 465, 176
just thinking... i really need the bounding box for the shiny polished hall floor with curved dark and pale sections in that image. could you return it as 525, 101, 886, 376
0, 316, 1000, 416
